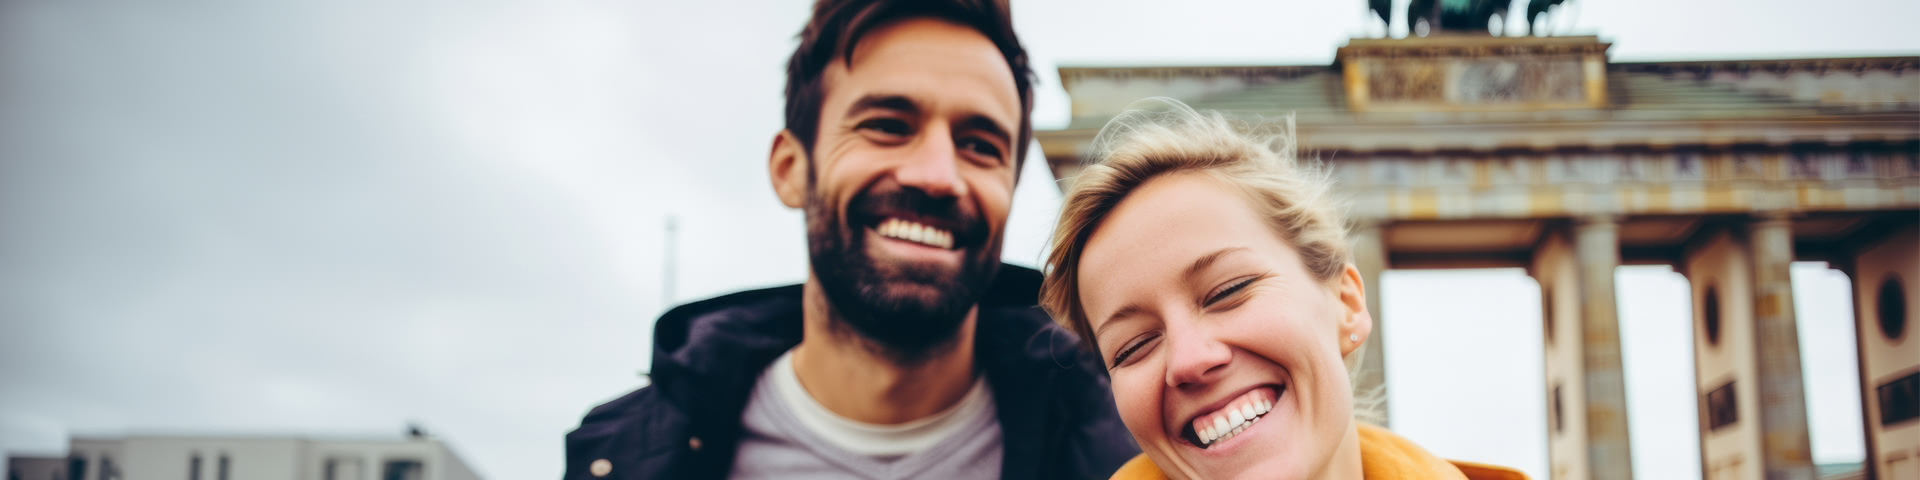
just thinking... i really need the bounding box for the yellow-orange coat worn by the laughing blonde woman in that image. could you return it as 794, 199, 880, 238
1114, 424, 1526, 480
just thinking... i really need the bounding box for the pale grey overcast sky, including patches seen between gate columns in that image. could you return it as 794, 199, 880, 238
0, 0, 1920, 478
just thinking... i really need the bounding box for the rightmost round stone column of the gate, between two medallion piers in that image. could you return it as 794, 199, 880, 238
1749, 213, 1814, 480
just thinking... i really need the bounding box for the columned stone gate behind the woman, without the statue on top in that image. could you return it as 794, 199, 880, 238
1037, 33, 1920, 480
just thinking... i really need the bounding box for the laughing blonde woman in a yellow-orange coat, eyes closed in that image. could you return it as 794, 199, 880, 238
1041, 98, 1524, 480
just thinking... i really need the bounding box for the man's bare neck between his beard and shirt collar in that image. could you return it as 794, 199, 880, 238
793, 280, 979, 424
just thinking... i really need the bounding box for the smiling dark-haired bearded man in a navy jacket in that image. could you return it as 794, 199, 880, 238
566, 0, 1139, 478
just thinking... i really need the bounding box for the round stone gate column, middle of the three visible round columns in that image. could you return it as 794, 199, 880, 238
1574, 217, 1634, 480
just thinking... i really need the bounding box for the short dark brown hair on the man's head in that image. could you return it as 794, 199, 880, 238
787, 0, 1033, 168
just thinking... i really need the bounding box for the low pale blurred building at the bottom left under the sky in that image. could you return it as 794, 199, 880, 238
6, 436, 480, 480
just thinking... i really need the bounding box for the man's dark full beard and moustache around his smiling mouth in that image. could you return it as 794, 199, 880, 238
806, 184, 1000, 359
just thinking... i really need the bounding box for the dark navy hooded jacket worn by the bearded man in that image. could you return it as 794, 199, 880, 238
566, 265, 1140, 480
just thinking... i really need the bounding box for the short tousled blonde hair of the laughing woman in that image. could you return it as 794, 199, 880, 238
1041, 98, 1365, 424
